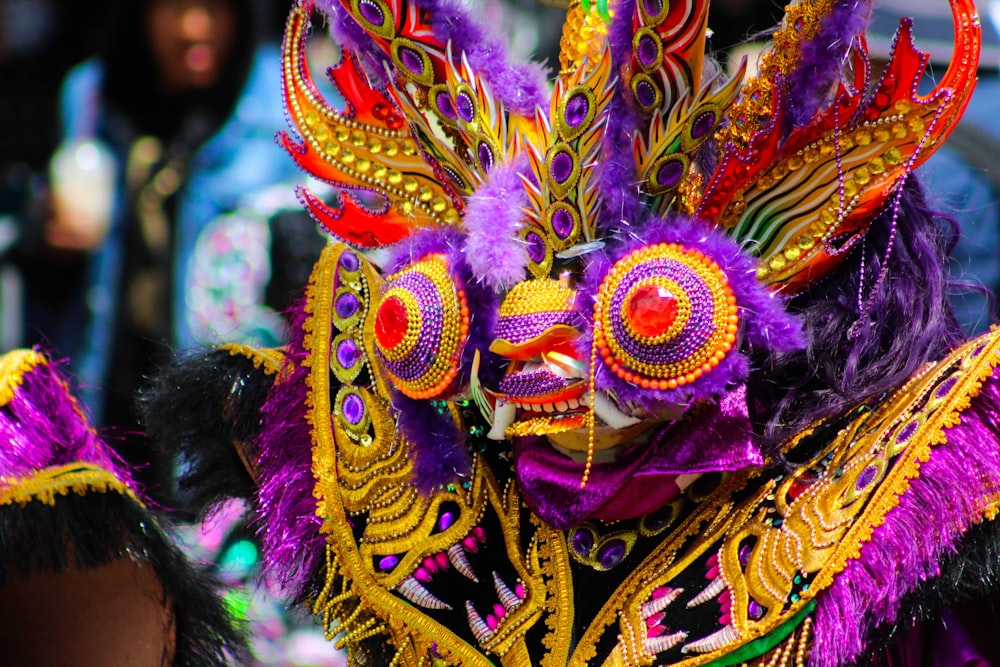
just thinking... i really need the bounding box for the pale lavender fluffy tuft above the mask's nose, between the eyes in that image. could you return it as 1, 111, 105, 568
464, 159, 528, 291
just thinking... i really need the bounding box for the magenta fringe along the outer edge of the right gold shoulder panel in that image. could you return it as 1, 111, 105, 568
810, 374, 1000, 667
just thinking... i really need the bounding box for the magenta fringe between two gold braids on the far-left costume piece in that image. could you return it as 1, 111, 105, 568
0, 352, 136, 490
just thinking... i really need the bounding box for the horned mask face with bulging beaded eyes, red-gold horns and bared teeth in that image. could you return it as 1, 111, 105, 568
280, 0, 979, 488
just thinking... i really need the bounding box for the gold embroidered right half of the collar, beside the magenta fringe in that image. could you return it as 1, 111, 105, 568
592, 329, 1000, 667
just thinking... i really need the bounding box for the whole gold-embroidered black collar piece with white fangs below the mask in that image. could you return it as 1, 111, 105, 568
304, 245, 1000, 667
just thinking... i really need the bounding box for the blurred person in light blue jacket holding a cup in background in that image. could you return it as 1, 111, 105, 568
18, 0, 301, 495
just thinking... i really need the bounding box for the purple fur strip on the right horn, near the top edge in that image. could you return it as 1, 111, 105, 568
787, 0, 872, 130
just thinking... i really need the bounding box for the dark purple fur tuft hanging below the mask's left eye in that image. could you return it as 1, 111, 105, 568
392, 392, 472, 495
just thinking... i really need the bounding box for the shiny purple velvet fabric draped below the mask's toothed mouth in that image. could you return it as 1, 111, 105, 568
514, 387, 764, 529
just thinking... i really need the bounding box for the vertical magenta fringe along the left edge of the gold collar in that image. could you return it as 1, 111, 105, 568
257, 304, 324, 594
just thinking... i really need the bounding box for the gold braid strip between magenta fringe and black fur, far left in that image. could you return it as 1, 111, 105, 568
0, 461, 143, 507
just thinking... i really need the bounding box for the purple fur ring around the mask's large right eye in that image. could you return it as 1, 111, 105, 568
575, 215, 805, 411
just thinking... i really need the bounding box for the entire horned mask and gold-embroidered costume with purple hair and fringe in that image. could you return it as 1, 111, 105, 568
145, 0, 1000, 667
